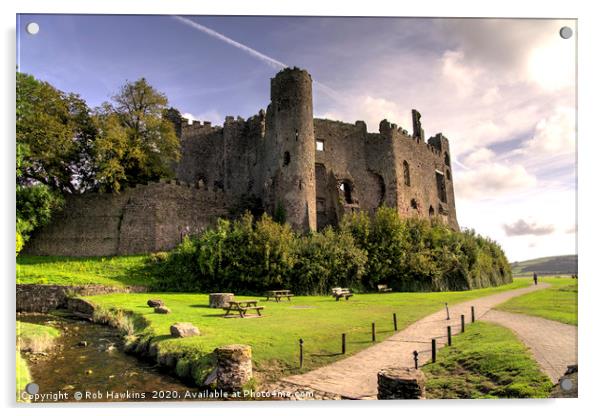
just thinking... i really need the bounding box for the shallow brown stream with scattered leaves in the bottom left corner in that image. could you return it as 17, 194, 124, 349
17, 314, 199, 402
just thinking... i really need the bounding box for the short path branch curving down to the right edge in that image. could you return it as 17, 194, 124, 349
481, 310, 577, 384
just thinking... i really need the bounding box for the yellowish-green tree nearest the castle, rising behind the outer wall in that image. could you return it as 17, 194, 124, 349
94, 78, 180, 191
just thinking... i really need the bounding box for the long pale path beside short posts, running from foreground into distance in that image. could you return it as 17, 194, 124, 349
282, 283, 549, 399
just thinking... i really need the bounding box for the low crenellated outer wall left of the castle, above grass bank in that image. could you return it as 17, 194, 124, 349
25, 183, 232, 256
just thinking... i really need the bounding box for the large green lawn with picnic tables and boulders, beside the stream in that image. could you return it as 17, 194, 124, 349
88, 280, 530, 377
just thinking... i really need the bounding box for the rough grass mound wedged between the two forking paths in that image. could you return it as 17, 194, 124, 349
422, 322, 552, 399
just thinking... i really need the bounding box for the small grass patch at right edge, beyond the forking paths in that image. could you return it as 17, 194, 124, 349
496, 277, 578, 325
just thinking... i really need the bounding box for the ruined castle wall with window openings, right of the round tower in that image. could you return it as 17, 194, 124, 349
314, 119, 459, 229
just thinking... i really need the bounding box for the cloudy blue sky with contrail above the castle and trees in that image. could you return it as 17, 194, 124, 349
17, 15, 576, 261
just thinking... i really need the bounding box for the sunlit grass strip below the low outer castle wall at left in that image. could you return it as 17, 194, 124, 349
17, 255, 152, 286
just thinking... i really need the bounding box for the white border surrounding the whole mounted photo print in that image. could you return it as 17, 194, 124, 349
0, 0, 602, 416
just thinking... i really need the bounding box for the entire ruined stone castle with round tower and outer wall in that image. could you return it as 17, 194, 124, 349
26, 68, 459, 256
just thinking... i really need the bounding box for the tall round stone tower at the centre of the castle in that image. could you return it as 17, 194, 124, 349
266, 68, 316, 231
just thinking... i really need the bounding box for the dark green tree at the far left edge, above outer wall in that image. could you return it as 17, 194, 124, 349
16, 72, 96, 194
